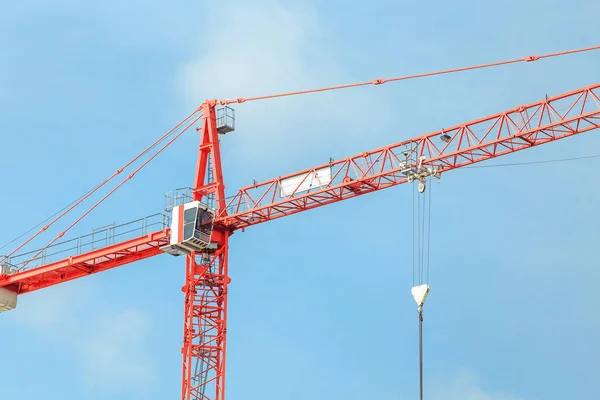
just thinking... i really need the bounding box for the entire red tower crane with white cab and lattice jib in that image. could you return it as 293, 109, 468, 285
0, 47, 600, 400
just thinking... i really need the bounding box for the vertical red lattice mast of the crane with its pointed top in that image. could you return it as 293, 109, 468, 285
181, 101, 231, 400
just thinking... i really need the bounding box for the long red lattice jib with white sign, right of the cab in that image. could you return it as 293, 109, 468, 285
215, 84, 600, 230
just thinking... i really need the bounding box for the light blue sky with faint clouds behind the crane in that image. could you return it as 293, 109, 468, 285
0, 0, 600, 400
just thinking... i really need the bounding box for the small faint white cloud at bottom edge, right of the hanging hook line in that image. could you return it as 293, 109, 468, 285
427, 372, 523, 400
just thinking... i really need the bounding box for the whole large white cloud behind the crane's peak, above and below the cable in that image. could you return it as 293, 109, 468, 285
178, 2, 390, 167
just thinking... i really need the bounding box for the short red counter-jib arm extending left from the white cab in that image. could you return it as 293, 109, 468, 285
0, 230, 169, 294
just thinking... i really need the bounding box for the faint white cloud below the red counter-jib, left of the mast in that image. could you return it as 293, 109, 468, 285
2, 282, 155, 391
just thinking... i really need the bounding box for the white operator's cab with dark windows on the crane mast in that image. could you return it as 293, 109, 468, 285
161, 201, 215, 256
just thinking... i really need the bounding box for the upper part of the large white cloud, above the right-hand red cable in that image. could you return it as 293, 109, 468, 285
183, 4, 324, 102
